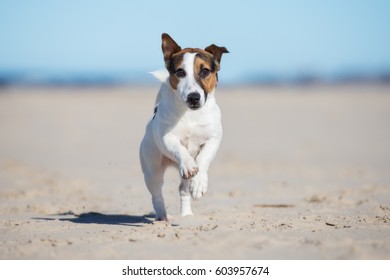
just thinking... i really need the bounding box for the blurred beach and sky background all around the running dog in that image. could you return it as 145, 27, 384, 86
0, 0, 390, 260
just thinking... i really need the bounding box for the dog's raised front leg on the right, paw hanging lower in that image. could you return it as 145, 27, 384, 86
190, 137, 221, 198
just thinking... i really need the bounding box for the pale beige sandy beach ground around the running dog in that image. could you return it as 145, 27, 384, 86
0, 85, 390, 259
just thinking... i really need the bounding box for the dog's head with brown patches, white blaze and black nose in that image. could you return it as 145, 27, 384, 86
162, 33, 228, 110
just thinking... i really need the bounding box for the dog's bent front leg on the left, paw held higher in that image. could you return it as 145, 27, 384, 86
161, 134, 199, 180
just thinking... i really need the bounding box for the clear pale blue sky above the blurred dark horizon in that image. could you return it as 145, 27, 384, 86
0, 0, 390, 82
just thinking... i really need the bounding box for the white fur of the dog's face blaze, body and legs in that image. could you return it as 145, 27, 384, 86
140, 53, 222, 220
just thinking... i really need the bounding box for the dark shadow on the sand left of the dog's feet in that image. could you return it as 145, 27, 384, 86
34, 211, 154, 227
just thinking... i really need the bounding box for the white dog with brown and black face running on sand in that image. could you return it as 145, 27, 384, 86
140, 33, 228, 221
